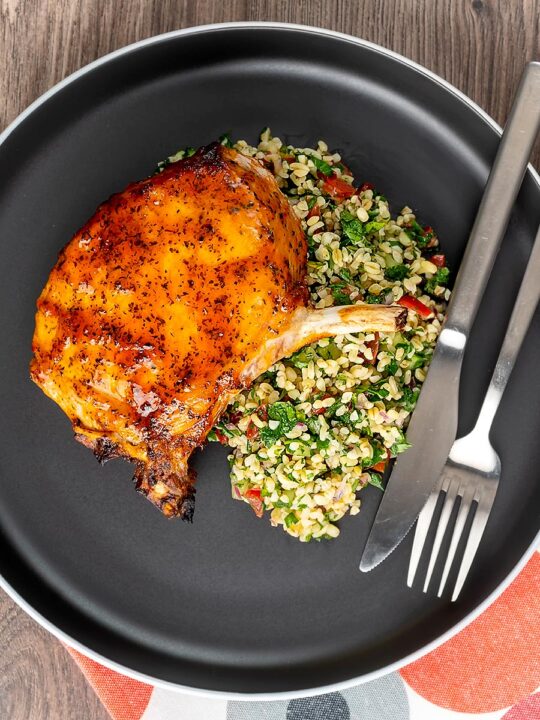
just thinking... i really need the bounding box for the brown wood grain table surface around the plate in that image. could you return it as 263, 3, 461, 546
0, 0, 540, 720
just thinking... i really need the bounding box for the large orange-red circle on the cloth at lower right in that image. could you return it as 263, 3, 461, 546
401, 553, 540, 720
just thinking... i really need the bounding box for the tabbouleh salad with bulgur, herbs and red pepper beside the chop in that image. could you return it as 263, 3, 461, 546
166, 128, 450, 542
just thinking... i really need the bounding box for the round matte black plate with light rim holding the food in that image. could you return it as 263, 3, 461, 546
0, 25, 540, 693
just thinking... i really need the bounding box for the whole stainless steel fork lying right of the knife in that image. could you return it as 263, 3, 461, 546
407, 222, 540, 601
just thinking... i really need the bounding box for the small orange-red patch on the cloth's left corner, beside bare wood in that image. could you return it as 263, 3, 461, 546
67, 647, 153, 720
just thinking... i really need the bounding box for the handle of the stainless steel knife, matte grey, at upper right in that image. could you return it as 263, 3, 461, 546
445, 62, 540, 337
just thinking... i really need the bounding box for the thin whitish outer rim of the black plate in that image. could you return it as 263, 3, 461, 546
0, 21, 540, 701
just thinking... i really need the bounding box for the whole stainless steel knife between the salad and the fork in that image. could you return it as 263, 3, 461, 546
360, 62, 540, 572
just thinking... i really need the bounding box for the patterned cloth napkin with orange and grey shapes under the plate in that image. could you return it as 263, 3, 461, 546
65, 553, 540, 720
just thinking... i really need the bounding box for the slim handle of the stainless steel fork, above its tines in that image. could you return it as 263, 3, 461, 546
475, 222, 540, 435
